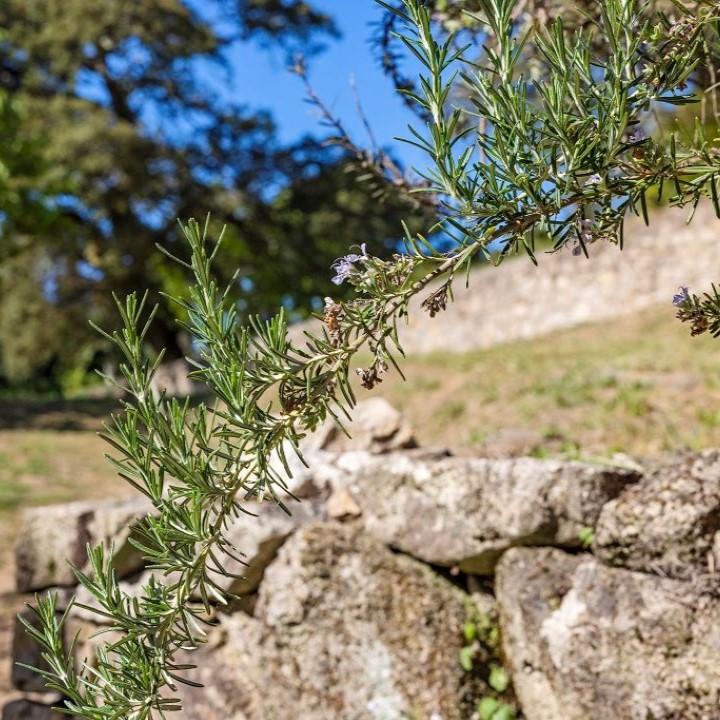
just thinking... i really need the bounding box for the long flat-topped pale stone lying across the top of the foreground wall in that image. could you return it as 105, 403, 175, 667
325, 453, 639, 574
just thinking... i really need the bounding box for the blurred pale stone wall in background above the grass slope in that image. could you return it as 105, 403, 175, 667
293, 204, 720, 353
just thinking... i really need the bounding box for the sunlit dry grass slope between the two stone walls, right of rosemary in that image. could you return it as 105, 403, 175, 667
366, 304, 720, 456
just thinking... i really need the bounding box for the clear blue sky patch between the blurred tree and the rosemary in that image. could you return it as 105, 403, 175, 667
217, 0, 426, 168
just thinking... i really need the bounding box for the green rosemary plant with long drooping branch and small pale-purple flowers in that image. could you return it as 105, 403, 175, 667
19, 0, 720, 720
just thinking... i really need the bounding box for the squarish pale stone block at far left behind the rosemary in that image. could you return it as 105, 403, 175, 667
15, 498, 151, 592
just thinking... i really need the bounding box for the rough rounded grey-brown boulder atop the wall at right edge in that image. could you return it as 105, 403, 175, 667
593, 450, 720, 578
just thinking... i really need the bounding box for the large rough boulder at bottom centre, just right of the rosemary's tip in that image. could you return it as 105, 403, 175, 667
183, 523, 481, 720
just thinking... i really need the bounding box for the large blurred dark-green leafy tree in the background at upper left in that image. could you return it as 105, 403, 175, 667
0, 0, 428, 390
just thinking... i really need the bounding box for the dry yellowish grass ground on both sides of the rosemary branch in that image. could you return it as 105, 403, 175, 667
0, 307, 720, 518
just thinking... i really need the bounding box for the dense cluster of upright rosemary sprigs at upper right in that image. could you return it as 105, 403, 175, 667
394, 0, 717, 257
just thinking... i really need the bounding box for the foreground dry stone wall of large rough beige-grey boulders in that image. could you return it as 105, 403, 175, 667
2, 405, 720, 720
